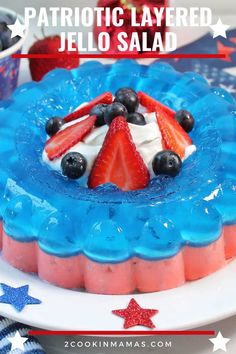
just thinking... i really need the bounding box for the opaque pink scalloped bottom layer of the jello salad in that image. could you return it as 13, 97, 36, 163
0, 225, 236, 294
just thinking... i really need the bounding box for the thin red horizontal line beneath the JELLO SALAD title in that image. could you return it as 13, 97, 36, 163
11, 53, 226, 59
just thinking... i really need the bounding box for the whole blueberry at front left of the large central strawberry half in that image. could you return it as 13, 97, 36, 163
61, 152, 87, 179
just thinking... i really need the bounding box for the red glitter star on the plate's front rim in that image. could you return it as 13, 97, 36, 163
112, 299, 158, 328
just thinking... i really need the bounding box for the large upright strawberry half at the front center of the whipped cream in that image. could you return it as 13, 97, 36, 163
88, 117, 150, 191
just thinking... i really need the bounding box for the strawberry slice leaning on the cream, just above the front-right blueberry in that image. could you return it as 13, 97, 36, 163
156, 111, 192, 159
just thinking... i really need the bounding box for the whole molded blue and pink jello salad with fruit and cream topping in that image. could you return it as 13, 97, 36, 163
0, 60, 236, 294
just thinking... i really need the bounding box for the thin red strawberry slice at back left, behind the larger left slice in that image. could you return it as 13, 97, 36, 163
64, 92, 113, 123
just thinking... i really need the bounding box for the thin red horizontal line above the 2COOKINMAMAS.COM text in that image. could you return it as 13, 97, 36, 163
28, 330, 215, 336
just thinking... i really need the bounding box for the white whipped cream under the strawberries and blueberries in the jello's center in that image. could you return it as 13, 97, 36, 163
42, 106, 196, 185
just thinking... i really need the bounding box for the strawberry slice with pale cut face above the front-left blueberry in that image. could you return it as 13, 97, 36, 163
45, 116, 96, 160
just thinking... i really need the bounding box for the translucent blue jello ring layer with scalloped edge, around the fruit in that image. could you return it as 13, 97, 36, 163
0, 60, 236, 263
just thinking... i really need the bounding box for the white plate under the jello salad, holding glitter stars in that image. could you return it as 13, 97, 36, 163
0, 258, 236, 330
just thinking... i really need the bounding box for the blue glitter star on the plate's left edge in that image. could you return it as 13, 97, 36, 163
0, 283, 42, 312
